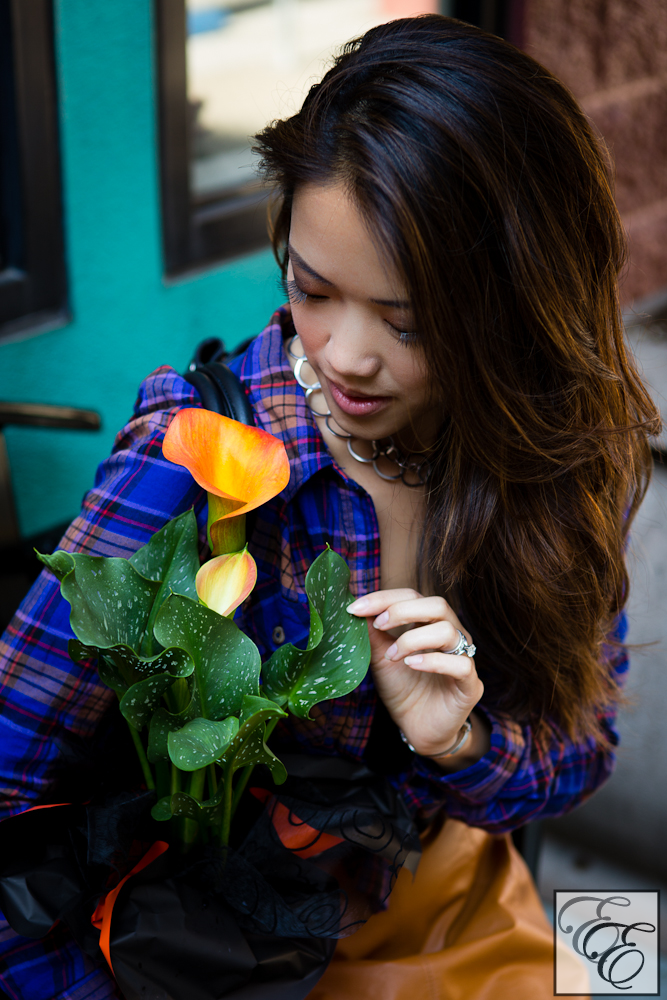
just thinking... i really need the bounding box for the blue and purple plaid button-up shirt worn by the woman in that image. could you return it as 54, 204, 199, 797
0, 308, 627, 1000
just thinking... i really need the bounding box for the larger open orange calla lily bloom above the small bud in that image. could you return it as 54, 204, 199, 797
162, 407, 289, 518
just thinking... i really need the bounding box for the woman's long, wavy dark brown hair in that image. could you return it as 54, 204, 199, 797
256, 15, 659, 746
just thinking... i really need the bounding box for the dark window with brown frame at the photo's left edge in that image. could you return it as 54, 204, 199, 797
0, 0, 69, 342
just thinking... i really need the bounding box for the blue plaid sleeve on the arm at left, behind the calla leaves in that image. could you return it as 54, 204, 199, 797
0, 368, 206, 1000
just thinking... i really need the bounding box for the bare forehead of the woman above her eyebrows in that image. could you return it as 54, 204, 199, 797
290, 183, 405, 299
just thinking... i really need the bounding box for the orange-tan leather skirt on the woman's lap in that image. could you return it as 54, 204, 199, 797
308, 819, 589, 1000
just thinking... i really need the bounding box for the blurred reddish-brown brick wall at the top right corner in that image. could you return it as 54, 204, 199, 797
522, 0, 667, 305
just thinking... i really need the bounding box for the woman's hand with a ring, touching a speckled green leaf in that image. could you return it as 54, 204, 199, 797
347, 589, 488, 765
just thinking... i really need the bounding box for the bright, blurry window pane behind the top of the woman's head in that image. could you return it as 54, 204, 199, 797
187, 0, 438, 199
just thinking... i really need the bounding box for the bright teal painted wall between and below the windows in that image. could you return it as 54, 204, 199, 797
0, 0, 280, 535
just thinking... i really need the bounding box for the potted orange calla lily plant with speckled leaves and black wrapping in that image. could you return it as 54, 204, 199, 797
0, 408, 419, 1000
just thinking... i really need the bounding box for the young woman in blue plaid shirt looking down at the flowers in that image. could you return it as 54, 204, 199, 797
0, 15, 657, 1000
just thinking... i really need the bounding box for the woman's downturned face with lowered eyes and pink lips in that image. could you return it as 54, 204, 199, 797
287, 184, 441, 449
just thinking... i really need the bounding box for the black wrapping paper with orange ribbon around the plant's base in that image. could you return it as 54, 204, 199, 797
0, 755, 420, 1000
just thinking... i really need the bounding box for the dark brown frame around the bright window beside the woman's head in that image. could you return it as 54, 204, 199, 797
154, 0, 270, 276
